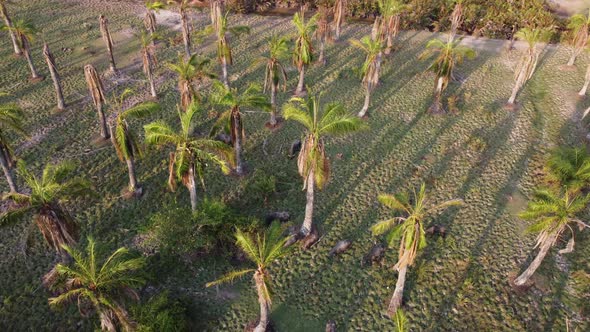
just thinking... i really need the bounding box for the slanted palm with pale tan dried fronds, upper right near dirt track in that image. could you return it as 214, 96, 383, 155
508, 28, 551, 106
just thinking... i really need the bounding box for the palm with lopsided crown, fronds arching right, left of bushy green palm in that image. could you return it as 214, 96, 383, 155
109, 89, 160, 195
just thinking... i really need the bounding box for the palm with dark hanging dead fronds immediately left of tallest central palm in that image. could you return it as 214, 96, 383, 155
211, 81, 271, 175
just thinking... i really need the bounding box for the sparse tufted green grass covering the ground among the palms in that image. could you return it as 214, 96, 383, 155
0, 0, 590, 331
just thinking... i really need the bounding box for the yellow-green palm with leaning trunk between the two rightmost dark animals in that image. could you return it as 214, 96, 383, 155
371, 183, 462, 317
